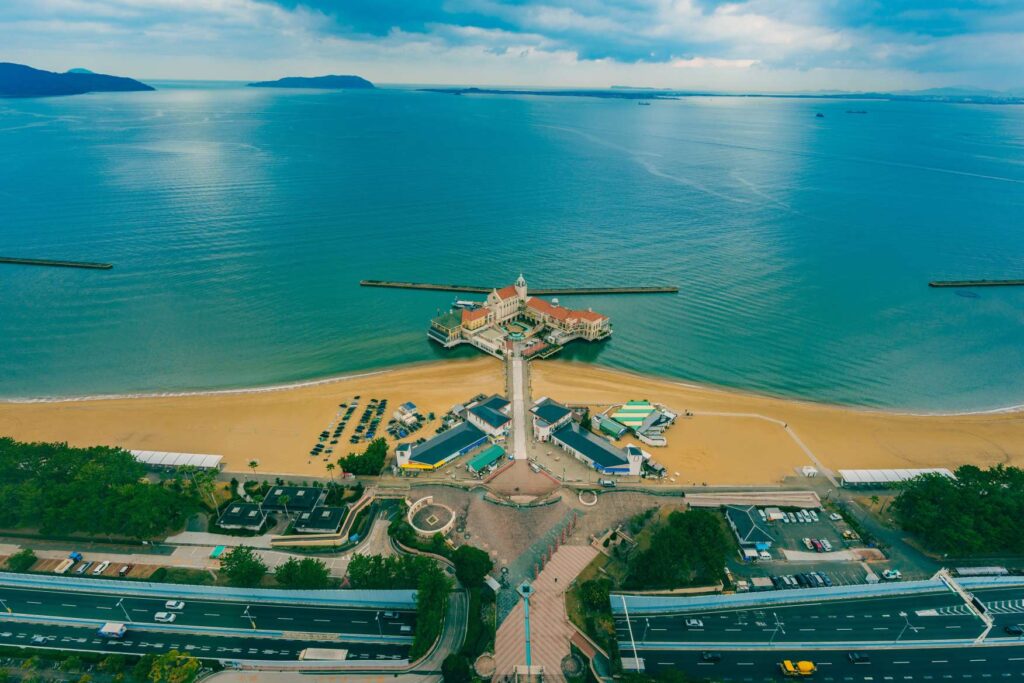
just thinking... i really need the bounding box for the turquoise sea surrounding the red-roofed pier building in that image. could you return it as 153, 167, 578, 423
0, 84, 1024, 411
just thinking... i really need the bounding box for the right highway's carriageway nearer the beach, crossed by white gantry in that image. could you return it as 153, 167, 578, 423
615, 589, 1024, 646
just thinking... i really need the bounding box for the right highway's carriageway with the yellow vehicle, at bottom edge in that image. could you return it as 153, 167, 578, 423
622, 645, 1024, 683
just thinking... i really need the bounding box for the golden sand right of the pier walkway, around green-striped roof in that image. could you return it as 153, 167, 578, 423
531, 361, 1024, 484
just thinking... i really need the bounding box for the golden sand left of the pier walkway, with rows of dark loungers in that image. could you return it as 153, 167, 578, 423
0, 356, 505, 477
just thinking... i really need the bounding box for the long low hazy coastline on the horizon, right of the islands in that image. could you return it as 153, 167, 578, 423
421, 86, 1024, 104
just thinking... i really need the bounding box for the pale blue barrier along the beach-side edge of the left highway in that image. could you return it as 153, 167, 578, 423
0, 572, 416, 610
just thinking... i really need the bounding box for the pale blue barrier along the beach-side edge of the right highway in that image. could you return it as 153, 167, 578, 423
610, 579, 949, 614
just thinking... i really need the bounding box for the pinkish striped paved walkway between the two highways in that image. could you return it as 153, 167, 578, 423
494, 546, 597, 681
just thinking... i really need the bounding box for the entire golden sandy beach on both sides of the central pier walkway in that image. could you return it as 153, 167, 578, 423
0, 357, 1024, 484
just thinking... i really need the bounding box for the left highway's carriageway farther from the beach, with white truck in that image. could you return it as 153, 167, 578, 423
0, 621, 409, 660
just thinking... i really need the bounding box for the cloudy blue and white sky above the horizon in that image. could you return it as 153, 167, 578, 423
0, 0, 1024, 92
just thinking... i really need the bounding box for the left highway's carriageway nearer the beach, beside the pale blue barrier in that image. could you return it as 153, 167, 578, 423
0, 586, 416, 637
